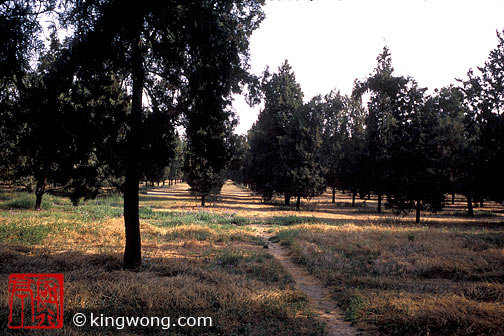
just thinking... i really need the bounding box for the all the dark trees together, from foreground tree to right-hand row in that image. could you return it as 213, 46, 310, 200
0, 0, 504, 269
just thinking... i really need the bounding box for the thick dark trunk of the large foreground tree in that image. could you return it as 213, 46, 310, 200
123, 38, 144, 269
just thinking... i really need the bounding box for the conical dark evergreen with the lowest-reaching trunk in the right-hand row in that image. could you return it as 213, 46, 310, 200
386, 78, 446, 223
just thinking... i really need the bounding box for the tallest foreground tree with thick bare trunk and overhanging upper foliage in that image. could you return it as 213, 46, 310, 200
63, 0, 264, 268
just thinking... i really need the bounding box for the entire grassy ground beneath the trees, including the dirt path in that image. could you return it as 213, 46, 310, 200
0, 182, 504, 335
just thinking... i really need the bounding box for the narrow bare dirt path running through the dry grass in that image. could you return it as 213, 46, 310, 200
254, 226, 362, 336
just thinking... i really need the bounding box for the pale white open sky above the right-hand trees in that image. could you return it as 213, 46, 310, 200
233, 0, 504, 134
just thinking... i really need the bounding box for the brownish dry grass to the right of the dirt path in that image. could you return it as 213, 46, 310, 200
276, 224, 504, 335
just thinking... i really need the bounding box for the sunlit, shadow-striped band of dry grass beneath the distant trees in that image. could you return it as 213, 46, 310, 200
140, 182, 504, 230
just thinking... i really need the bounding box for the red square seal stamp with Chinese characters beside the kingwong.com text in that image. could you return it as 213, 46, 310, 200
8, 273, 63, 329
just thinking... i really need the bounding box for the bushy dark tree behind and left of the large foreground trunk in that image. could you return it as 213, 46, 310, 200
11, 32, 131, 209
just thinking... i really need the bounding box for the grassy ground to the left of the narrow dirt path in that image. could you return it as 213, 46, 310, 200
0, 186, 323, 335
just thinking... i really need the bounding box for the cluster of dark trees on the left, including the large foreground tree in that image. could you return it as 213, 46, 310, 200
0, 0, 264, 268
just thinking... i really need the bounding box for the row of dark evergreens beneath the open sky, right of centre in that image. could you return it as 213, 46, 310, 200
234, 33, 504, 222
